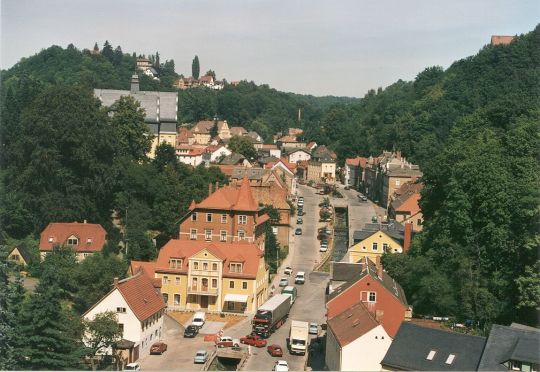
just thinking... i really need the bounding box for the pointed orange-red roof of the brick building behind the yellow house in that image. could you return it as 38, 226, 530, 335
196, 177, 259, 212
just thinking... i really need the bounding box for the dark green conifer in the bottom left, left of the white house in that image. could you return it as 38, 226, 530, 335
18, 282, 84, 370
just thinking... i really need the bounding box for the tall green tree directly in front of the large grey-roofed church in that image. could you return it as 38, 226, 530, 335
111, 96, 152, 161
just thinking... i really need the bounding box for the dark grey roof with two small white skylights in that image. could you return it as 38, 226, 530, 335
381, 322, 486, 371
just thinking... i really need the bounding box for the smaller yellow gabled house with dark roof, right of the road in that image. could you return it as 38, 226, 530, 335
349, 225, 403, 263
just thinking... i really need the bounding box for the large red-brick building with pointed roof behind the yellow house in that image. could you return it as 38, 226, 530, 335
179, 177, 269, 251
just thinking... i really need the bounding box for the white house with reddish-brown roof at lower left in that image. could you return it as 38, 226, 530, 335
83, 271, 166, 362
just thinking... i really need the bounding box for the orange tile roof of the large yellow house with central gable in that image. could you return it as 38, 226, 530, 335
156, 239, 264, 279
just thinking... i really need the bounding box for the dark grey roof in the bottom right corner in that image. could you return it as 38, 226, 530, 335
478, 324, 540, 371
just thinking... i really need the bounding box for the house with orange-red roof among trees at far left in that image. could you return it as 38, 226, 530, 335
39, 220, 107, 262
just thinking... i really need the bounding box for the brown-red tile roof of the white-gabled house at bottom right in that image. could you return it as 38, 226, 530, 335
327, 302, 379, 347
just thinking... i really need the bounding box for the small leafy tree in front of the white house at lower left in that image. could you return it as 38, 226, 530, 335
83, 311, 122, 371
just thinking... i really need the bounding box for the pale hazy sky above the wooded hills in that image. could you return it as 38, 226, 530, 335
0, 0, 540, 97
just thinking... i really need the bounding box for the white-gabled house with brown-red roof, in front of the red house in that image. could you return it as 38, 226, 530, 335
325, 302, 392, 371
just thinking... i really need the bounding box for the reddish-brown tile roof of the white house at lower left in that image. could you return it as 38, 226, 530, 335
114, 271, 166, 322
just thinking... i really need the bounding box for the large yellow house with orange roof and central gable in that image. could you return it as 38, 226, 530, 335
132, 239, 268, 313
